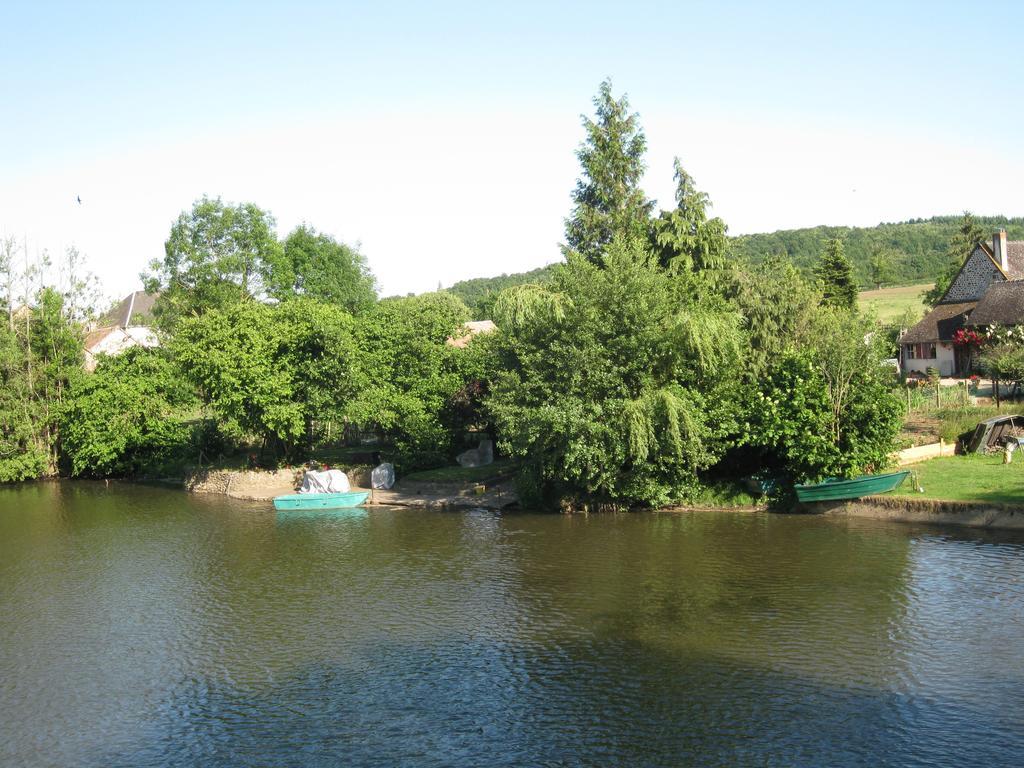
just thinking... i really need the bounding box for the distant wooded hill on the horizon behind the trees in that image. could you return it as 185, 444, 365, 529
449, 215, 1024, 319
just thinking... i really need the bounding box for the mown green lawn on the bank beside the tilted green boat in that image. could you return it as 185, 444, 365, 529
893, 453, 1024, 504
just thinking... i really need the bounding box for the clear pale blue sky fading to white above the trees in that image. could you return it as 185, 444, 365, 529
0, 2, 1024, 293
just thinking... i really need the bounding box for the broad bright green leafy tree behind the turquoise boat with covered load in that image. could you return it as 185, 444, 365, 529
172, 298, 364, 459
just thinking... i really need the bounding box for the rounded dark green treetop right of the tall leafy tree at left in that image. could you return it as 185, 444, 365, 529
271, 224, 377, 313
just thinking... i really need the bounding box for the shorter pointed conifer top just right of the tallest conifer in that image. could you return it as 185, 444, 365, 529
651, 158, 728, 270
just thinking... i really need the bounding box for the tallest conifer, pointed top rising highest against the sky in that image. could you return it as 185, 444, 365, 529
565, 80, 654, 263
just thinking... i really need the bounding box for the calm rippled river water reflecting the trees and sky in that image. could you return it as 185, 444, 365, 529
0, 483, 1024, 768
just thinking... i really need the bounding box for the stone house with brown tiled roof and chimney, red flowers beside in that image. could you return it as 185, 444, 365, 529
900, 229, 1024, 376
